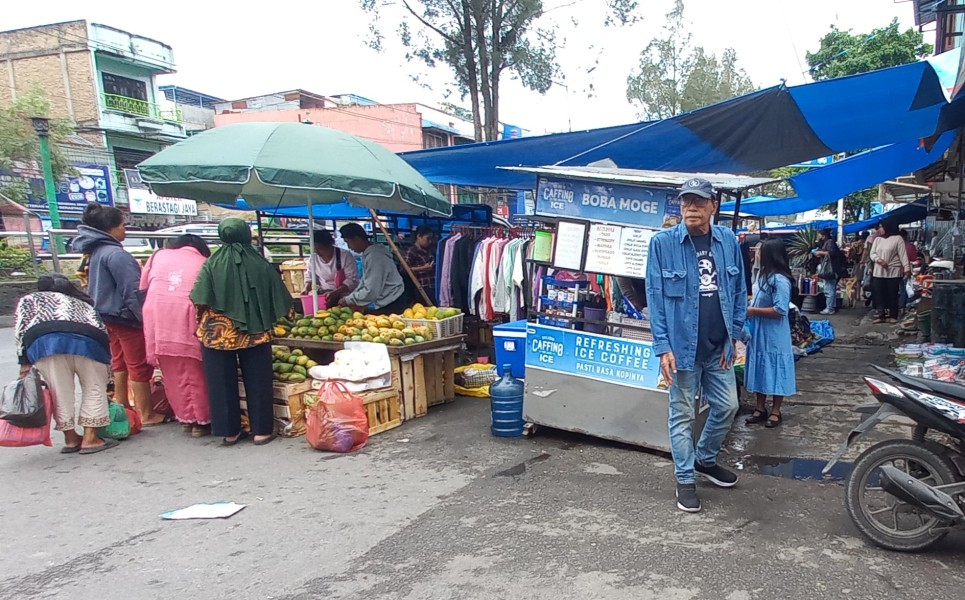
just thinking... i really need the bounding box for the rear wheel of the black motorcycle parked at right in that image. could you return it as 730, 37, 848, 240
845, 440, 958, 552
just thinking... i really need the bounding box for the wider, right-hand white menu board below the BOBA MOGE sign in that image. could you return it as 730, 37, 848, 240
585, 224, 656, 279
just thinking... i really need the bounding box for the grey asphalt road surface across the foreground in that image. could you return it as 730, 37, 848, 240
0, 329, 965, 600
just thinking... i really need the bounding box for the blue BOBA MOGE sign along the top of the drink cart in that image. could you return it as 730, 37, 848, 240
536, 177, 680, 229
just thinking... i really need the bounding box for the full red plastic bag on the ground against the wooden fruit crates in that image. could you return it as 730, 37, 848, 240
305, 381, 369, 452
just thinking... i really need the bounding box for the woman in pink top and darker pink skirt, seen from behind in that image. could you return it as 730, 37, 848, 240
141, 235, 211, 437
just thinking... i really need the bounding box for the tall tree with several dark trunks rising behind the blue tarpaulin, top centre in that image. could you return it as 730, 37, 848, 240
359, 0, 637, 140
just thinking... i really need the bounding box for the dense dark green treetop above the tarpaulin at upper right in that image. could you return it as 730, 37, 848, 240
806, 19, 933, 81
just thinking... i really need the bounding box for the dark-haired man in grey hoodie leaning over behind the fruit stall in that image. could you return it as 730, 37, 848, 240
339, 223, 406, 315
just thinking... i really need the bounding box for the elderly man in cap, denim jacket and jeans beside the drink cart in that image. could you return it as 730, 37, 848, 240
647, 178, 747, 512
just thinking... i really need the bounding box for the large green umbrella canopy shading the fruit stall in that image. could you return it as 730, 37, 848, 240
138, 123, 452, 216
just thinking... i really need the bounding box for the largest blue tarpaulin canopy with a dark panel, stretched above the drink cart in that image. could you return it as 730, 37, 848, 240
401, 50, 965, 189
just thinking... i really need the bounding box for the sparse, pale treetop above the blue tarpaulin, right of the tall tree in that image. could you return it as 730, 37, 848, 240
627, 0, 754, 119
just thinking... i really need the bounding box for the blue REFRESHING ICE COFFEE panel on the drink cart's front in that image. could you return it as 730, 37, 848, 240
526, 323, 661, 390
